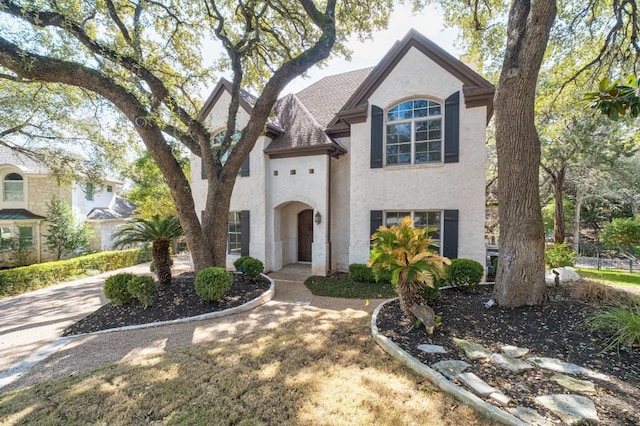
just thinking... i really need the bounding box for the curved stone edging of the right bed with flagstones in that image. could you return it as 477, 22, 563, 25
371, 298, 527, 426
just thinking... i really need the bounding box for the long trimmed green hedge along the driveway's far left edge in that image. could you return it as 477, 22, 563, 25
0, 248, 150, 298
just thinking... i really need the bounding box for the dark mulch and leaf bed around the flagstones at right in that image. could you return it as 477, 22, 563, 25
377, 286, 640, 425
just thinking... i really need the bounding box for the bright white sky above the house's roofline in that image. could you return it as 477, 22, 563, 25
281, 5, 463, 95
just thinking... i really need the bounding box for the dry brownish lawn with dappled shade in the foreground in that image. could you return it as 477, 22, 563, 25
0, 309, 487, 425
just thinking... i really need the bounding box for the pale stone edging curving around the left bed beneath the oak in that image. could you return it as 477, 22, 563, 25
0, 274, 275, 390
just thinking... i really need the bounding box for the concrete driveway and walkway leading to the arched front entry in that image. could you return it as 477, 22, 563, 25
0, 256, 381, 392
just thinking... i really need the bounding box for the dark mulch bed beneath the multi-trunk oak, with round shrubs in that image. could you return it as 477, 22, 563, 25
63, 272, 270, 336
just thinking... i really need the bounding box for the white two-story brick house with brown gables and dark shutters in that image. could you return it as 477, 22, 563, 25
191, 30, 494, 275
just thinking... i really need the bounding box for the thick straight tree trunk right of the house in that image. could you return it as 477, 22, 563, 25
493, 0, 556, 307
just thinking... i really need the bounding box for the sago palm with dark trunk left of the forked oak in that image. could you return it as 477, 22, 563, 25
112, 215, 182, 285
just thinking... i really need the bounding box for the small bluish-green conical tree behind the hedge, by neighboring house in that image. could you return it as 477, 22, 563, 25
46, 198, 94, 260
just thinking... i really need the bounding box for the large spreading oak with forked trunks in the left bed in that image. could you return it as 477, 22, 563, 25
0, 0, 392, 270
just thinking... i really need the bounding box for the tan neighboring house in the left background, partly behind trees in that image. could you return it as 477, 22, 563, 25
0, 146, 135, 266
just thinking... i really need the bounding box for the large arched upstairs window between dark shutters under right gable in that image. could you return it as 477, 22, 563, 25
386, 99, 442, 165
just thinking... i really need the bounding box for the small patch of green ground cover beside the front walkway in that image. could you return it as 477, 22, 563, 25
304, 274, 398, 299
